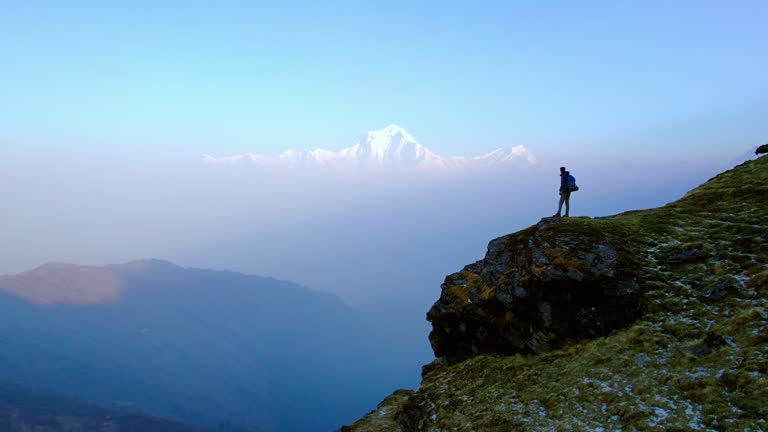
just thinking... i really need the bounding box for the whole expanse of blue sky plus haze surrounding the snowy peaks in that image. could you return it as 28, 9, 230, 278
0, 1, 768, 304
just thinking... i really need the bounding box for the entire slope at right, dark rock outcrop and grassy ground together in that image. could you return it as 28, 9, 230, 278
342, 157, 768, 432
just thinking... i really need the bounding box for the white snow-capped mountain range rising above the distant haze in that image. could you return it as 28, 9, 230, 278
202, 125, 536, 169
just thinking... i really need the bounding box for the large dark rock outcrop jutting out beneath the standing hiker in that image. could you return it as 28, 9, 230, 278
427, 219, 641, 364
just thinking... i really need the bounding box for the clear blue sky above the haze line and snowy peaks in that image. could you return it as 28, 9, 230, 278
0, 1, 768, 158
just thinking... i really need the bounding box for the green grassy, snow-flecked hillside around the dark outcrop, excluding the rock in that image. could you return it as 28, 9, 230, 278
344, 158, 768, 431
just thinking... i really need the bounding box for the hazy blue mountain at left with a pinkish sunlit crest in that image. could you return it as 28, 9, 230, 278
0, 260, 424, 431
